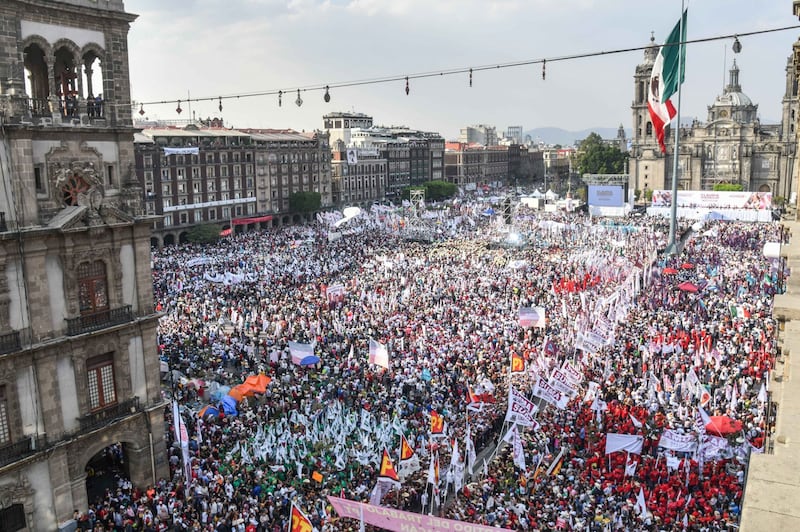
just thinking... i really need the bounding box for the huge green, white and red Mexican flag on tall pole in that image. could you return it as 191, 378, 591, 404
647, 11, 686, 153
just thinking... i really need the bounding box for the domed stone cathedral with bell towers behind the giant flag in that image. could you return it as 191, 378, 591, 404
628, 33, 798, 200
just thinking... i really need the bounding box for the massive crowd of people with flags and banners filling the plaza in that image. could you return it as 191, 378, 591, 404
84, 197, 784, 531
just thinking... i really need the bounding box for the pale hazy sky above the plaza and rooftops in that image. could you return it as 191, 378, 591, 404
125, 0, 800, 139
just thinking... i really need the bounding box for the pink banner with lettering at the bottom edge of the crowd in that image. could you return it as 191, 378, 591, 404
328, 496, 509, 532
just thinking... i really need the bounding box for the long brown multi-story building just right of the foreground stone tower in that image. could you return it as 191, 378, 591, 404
135, 124, 332, 246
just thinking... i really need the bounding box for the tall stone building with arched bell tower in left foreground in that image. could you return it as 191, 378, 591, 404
0, 0, 168, 531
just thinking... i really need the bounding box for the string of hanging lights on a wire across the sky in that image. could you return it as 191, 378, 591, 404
134, 25, 800, 116
